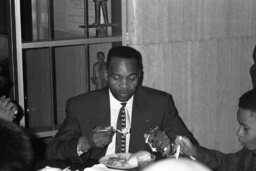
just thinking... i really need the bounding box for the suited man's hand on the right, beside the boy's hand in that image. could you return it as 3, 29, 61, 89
144, 130, 170, 155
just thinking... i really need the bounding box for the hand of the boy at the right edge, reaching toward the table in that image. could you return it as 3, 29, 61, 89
175, 136, 196, 156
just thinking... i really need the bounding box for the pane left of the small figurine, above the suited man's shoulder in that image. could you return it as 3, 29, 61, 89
55, 45, 88, 124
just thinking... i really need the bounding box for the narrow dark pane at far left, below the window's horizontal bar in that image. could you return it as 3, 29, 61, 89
24, 48, 53, 128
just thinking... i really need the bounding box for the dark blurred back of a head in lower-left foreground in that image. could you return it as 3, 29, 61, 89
0, 119, 33, 171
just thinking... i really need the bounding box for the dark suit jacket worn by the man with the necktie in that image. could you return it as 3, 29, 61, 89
46, 86, 197, 162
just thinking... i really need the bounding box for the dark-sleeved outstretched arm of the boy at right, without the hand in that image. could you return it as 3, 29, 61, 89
196, 146, 243, 171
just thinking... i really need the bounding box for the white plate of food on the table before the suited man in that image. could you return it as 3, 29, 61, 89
99, 153, 138, 170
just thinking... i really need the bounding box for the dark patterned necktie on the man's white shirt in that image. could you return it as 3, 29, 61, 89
116, 103, 126, 153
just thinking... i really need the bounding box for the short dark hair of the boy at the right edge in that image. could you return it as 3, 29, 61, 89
238, 89, 256, 112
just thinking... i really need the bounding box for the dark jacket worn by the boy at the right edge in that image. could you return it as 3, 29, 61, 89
196, 147, 256, 171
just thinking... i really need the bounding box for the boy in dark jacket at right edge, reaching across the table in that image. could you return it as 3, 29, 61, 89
175, 90, 256, 171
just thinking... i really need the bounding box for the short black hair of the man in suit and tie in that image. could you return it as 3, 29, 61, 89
107, 46, 143, 71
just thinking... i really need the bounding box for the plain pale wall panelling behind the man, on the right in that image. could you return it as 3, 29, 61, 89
127, 0, 256, 152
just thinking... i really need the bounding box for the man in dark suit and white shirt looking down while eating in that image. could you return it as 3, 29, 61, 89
46, 46, 197, 162
